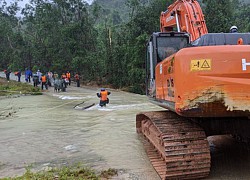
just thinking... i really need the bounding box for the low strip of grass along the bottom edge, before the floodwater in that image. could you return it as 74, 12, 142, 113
1, 165, 117, 180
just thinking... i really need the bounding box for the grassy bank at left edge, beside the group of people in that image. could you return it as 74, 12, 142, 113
0, 78, 42, 96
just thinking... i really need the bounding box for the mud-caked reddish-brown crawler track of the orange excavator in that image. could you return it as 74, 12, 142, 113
136, 111, 211, 179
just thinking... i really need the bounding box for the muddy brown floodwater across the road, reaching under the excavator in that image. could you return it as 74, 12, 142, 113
0, 73, 250, 180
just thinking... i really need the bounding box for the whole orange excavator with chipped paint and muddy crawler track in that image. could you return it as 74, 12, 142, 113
136, 0, 250, 179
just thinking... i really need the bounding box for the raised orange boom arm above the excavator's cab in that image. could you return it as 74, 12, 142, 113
160, 0, 208, 41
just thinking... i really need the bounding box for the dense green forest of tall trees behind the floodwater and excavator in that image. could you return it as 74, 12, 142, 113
0, 0, 250, 93
